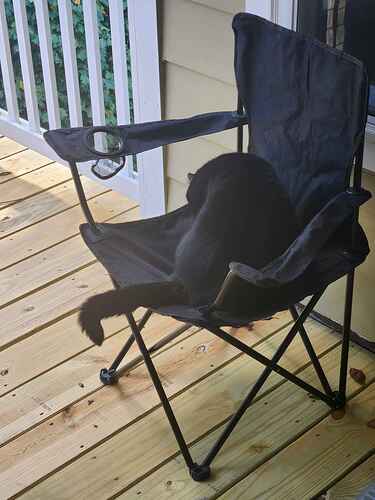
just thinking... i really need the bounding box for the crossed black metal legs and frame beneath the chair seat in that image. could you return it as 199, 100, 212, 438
97, 286, 353, 481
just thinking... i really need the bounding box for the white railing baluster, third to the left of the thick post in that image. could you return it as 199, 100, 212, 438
58, 0, 82, 127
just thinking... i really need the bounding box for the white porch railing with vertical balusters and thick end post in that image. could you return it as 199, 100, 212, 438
0, 0, 165, 216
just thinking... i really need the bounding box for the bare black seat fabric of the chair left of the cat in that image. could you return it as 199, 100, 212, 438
80, 205, 217, 325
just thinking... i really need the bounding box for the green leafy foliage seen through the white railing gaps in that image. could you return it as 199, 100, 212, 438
0, 0, 133, 128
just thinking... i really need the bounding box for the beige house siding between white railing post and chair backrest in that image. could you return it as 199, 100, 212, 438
158, 0, 245, 211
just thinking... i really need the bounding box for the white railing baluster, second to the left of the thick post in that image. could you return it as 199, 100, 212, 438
83, 0, 105, 130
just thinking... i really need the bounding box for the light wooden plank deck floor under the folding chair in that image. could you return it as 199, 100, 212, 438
0, 138, 375, 500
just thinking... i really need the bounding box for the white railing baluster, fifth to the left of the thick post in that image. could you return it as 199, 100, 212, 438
13, 0, 40, 132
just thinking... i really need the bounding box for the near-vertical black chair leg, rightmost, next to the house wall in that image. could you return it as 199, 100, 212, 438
337, 270, 354, 407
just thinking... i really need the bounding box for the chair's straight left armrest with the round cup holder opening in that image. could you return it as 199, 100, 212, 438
44, 111, 248, 162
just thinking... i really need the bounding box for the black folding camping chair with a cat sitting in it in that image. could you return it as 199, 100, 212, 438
45, 14, 371, 481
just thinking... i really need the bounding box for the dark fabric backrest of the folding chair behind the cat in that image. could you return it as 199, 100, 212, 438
233, 14, 368, 224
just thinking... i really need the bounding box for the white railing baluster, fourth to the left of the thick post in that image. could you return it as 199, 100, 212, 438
34, 0, 61, 129
